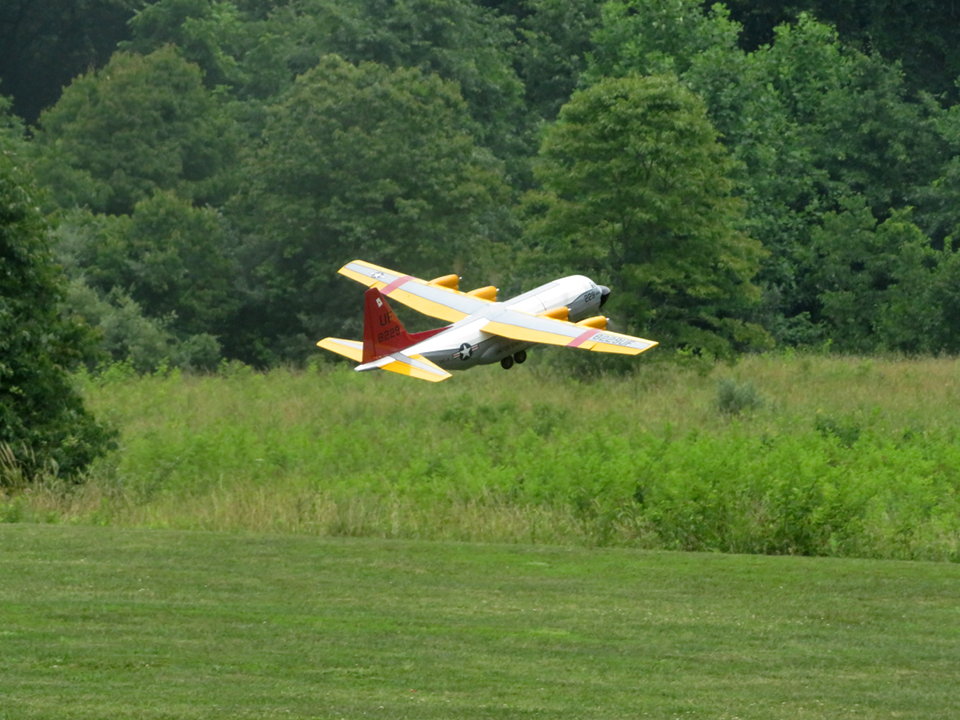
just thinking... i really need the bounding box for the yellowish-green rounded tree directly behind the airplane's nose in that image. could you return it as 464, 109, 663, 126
527, 75, 762, 355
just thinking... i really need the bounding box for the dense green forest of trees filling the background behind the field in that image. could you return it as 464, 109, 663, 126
0, 0, 960, 370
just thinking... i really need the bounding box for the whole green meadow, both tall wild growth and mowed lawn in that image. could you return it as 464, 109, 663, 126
0, 355, 960, 720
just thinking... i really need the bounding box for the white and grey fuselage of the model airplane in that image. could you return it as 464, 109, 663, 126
404, 275, 603, 370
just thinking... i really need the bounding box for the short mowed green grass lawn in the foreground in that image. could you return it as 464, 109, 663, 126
0, 525, 960, 720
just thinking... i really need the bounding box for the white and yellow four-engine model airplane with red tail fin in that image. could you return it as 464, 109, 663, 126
317, 260, 657, 382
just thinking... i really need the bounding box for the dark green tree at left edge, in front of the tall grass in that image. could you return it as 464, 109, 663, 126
0, 153, 112, 484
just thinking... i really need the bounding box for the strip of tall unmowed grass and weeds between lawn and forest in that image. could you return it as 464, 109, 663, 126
0, 355, 960, 561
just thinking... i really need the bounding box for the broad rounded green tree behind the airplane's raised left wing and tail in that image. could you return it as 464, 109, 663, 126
229, 56, 506, 362
